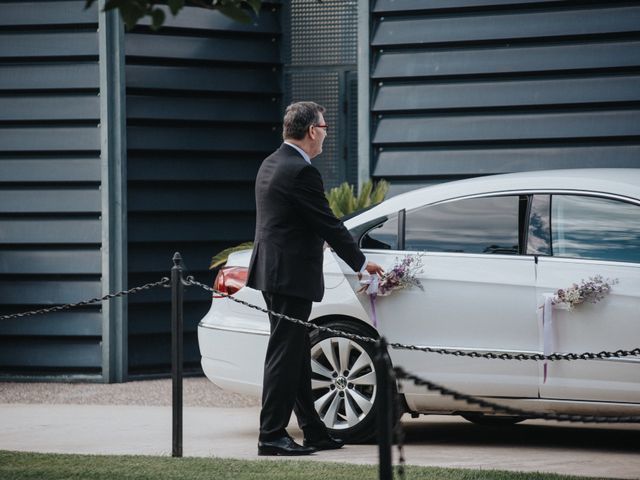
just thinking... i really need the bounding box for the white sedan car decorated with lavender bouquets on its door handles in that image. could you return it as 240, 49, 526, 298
198, 169, 640, 441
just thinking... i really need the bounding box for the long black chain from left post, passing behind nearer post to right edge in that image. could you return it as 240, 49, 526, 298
185, 277, 640, 361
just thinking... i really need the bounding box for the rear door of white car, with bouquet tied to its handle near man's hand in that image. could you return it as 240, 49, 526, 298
350, 195, 538, 398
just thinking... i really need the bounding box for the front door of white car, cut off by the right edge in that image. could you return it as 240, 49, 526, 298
529, 193, 640, 403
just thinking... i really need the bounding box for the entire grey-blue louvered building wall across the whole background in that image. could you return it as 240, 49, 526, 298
10, 0, 640, 381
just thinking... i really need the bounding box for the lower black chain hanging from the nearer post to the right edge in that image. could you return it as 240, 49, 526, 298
393, 367, 640, 423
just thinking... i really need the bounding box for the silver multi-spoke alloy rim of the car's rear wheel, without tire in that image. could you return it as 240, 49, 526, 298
311, 337, 377, 430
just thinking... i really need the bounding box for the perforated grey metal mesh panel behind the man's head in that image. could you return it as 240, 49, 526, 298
284, 0, 358, 189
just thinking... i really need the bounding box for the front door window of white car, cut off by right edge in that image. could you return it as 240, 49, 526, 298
551, 195, 640, 263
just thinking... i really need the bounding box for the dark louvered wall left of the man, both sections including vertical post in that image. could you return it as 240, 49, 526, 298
0, 0, 282, 381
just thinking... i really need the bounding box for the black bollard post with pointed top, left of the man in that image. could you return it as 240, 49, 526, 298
171, 252, 184, 457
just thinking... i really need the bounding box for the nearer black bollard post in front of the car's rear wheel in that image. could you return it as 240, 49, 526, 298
374, 337, 393, 480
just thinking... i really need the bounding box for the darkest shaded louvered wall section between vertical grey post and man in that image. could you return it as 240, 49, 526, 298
125, 2, 282, 376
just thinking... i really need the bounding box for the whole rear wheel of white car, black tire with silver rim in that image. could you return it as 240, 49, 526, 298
310, 320, 400, 443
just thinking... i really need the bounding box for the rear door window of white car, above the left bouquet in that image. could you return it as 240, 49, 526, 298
405, 195, 526, 255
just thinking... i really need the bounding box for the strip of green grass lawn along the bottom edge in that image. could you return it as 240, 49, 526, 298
0, 451, 620, 480
